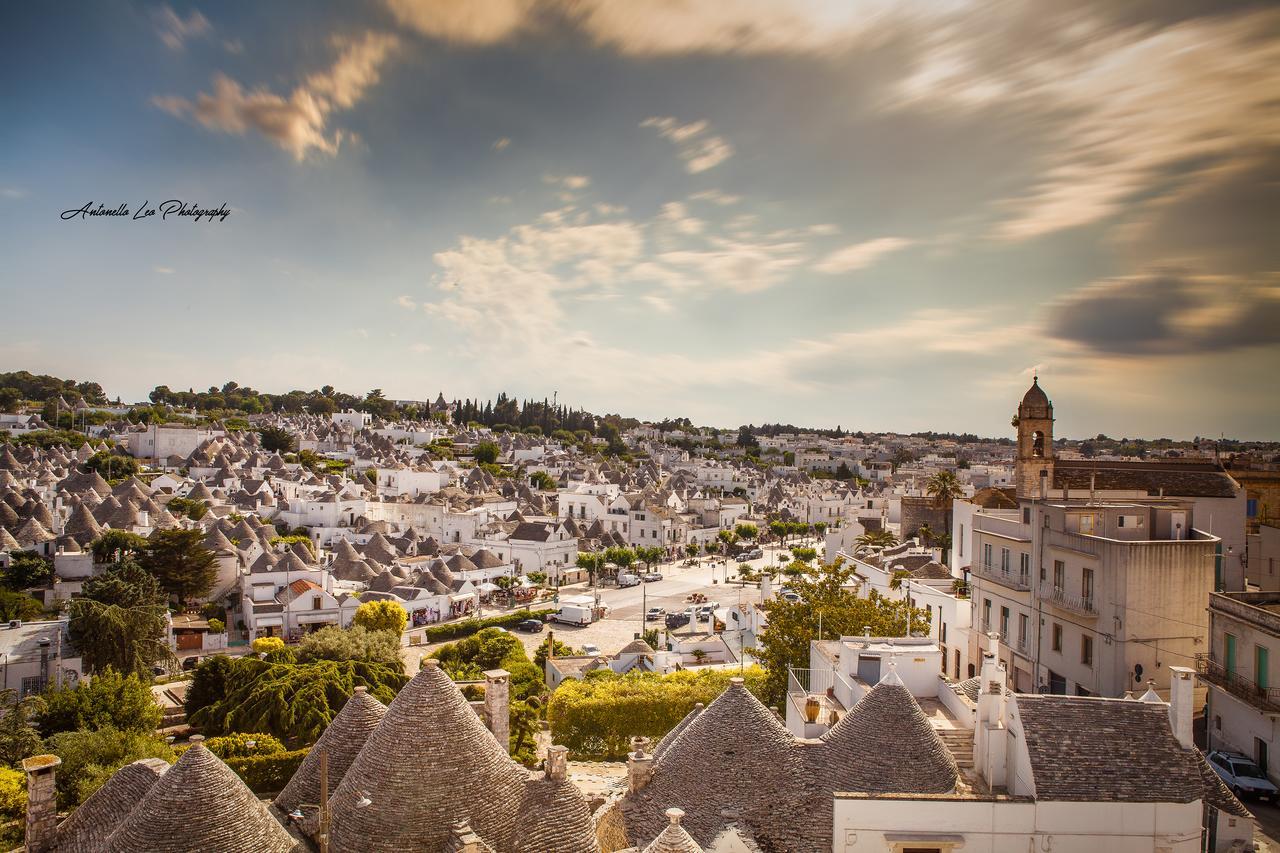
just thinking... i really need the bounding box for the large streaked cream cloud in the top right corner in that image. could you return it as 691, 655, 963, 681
883, 4, 1280, 241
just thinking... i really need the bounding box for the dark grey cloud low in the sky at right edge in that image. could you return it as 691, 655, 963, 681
1047, 270, 1280, 355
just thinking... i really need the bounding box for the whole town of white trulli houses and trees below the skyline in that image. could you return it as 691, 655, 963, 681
0, 373, 1280, 850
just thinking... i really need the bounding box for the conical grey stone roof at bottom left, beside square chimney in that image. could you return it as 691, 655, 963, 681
104, 735, 297, 853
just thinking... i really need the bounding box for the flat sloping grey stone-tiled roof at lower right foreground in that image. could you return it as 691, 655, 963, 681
1014, 694, 1204, 803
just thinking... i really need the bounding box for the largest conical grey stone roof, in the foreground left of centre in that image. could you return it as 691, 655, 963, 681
329, 661, 529, 852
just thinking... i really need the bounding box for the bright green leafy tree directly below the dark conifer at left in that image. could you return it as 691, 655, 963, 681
36, 669, 164, 738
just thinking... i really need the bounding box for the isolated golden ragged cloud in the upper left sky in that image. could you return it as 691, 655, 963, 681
151, 32, 399, 161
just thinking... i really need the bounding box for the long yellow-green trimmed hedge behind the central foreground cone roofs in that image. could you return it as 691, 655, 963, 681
547, 666, 764, 761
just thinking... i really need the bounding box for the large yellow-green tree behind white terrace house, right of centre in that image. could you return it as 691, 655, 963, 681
747, 560, 929, 701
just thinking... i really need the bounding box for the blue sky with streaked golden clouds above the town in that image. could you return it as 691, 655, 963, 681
0, 0, 1280, 439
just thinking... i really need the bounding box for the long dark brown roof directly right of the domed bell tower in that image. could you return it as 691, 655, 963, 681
1053, 459, 1240, 498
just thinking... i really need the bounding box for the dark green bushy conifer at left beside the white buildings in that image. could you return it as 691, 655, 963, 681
67, 562, 173, 676
